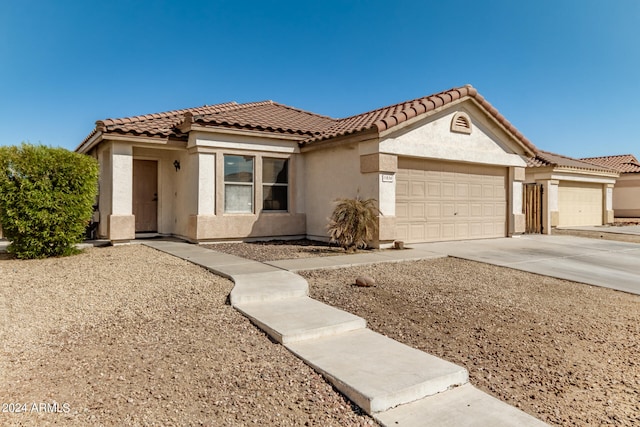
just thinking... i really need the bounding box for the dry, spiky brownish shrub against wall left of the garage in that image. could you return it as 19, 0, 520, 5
327, 197, 380, 252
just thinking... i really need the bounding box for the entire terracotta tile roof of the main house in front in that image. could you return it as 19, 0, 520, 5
78, 85, 536, 152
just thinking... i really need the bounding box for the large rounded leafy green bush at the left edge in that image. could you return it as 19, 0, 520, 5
0, 144, 98, 259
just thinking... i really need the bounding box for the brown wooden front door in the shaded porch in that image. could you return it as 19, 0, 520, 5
133, 160, 158, 233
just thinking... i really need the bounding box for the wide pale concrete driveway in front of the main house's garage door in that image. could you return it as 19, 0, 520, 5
416, 235, 640, 295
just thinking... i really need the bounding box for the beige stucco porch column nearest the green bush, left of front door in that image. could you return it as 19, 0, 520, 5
108, 143, 136, 243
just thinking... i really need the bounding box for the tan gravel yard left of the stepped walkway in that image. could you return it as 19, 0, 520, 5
0, 245, 375, 426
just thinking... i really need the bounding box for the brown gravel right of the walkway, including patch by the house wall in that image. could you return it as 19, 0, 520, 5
205, 236, 640, 426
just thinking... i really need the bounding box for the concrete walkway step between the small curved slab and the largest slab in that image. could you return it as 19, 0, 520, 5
235, 297, 367, 344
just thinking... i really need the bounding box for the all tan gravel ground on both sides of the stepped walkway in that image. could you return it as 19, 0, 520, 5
0, 242, 640, 426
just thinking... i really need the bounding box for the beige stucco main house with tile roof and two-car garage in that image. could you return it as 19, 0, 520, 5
76, 85, 536, 246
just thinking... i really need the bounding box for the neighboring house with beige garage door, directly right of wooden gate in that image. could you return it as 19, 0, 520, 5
525, 150, 618, 234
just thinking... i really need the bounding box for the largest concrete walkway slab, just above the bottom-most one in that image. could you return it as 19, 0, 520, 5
285, 329, 469, 414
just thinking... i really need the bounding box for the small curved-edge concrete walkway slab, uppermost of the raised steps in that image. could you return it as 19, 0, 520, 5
230, 270, 309, 307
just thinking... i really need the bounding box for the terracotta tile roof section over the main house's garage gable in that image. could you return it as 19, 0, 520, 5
305, 85, 536, 152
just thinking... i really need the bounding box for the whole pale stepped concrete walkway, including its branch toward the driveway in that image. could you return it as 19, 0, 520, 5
144, 241, 546, 426
